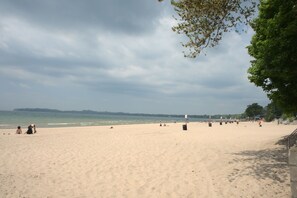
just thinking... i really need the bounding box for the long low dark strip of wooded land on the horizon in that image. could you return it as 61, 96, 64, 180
13, 108, 241, 119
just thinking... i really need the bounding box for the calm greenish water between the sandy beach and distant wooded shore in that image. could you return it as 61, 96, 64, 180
0, 111, 192, 129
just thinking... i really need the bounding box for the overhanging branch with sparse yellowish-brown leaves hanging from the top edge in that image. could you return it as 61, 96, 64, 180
159, 0, 257, 58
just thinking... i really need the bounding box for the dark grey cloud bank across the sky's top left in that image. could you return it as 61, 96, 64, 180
0, 0, 162, 34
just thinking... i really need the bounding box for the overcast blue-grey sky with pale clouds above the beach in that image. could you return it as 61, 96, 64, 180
0, 0, 269, 115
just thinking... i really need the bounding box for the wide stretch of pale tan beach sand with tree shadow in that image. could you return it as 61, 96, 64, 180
0, 123, 296, 198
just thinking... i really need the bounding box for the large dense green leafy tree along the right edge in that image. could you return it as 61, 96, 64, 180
248, 0, 297, 113
